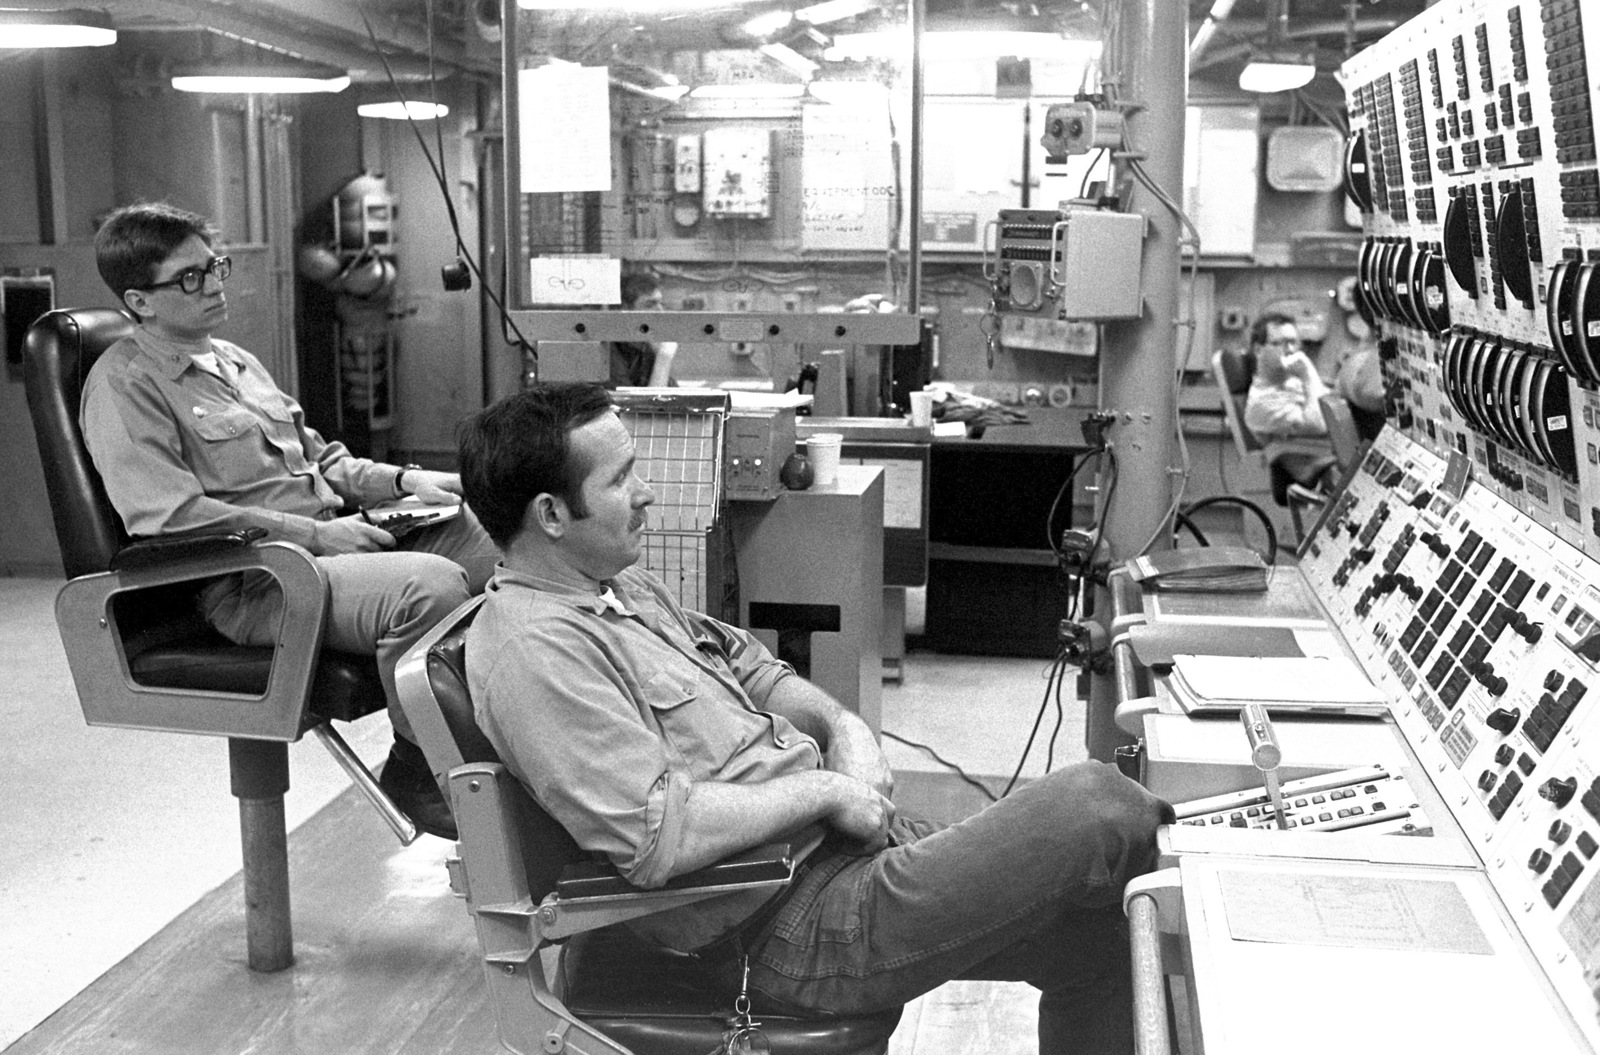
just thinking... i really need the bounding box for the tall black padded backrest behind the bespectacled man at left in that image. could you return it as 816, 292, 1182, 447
22, 307, 136, 578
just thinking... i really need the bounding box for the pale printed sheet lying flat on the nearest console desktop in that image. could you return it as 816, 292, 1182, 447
1218, 871, 1494, 956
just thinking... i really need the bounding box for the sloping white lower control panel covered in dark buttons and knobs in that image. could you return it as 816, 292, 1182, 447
1301, 429, 1600, 1047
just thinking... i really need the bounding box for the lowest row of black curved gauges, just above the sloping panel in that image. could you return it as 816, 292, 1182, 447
1445, 330, 1578, 477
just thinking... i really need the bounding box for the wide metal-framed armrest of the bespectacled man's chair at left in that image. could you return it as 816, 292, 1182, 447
56, 541, 328, 741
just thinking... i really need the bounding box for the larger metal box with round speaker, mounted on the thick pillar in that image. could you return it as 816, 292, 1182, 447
984, 205, 1146, 320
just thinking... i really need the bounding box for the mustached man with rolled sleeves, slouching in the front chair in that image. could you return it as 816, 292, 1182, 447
461, 384, 1171, 1055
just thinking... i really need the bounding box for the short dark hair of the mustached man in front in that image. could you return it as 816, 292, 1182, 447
456, 381, 611, 549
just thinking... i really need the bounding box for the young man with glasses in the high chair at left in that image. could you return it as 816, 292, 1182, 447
80, 203, 498, 837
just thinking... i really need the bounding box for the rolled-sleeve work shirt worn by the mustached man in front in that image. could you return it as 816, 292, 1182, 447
466, 567, 822, 951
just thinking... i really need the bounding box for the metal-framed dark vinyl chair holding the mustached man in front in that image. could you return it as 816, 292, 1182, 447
395, 599, 901, 1055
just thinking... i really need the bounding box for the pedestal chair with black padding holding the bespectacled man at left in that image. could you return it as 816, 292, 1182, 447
22, 309, 416, 970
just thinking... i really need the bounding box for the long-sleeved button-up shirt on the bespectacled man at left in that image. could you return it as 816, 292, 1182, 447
80, 328, 400, 552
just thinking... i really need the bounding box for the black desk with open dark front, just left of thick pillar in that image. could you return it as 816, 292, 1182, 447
925, 407, 1093, 658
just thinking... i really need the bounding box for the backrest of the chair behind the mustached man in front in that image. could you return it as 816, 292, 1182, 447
406, 597, 592, 903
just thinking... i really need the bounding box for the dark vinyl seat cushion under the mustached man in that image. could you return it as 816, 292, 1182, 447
562, 927, 901, 1055
